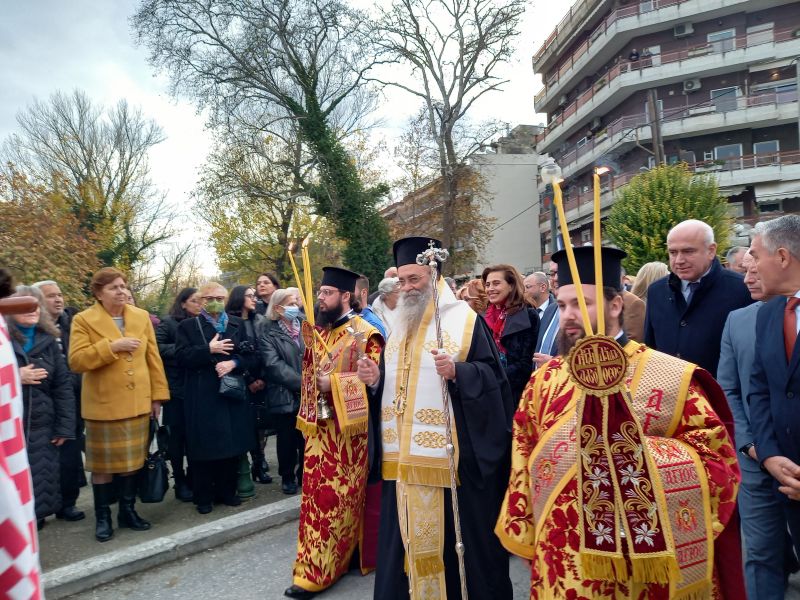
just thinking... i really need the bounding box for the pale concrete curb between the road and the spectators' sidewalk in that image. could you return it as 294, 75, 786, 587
42, 495, 300, 600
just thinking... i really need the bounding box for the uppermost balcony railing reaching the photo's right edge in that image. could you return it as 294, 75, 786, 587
541, 26, 797, 139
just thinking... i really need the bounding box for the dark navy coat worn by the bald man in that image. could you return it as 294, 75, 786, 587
644, 258, 753, 377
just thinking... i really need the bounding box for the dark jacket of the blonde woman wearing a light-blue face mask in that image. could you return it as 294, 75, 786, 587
259, 322, 304, 415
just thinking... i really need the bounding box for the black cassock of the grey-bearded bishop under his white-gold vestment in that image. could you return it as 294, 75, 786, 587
370, 317, 516, 600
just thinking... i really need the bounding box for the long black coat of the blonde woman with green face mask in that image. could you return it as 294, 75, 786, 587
175, 316, 258, 460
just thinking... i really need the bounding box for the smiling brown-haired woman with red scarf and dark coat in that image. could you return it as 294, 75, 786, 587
481, 265, 539, 399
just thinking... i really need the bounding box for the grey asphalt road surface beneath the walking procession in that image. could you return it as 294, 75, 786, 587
69, 521, 528, 600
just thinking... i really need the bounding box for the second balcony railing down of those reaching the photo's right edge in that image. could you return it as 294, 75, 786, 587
555, 90, 797, 169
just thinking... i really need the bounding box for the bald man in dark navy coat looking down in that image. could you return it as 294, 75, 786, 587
645, 219, 752, 376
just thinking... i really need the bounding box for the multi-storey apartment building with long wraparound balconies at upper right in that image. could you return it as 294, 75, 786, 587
533, 0, 800, 251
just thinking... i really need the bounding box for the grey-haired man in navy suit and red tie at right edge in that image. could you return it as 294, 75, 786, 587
748, 215, 800, 555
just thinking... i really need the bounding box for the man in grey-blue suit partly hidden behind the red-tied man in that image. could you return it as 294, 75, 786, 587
717, 254, 797, 600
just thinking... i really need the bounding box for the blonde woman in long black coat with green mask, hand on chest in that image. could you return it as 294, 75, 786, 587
175, 282, 258, 515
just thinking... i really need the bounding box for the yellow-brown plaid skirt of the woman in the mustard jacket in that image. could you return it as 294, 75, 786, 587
86, 415, 150, 473
